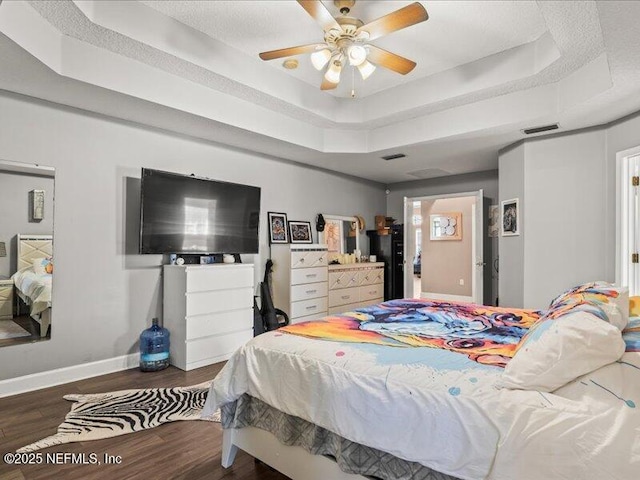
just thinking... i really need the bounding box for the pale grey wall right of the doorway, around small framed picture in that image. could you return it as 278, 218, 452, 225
499, 113, 640, 308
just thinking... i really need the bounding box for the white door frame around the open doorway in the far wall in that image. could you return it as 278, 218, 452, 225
403, 189, 484, 305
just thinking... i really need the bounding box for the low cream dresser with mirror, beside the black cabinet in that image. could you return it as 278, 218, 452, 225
329, 262, 384, 315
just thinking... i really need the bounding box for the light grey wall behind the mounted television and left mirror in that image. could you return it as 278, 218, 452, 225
0, 94, 386, 380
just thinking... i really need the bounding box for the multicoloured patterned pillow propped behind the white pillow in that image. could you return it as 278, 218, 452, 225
545, 282, 629, 330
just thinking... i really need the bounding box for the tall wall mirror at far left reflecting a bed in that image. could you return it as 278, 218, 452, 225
0, 160, 55, 347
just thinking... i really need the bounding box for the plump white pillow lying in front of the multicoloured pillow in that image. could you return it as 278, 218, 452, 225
498, 311, 625, 392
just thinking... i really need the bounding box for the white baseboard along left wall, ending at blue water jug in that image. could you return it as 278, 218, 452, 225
0, 353, 140, 398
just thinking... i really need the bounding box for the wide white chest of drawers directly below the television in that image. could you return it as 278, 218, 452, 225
163, 263, 254, 370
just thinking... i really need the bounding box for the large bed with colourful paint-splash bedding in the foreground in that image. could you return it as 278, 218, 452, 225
203, 285, 640, 480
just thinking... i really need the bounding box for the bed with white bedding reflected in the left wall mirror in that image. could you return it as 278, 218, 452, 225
11, 234, 53, 337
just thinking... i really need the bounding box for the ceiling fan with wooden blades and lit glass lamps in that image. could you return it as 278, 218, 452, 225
260, 0, 429, 90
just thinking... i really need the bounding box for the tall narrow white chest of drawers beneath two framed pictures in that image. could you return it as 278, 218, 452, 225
271, 244, 328, 323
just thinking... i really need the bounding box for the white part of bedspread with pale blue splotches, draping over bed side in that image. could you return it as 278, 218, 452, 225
203, 332, 640, 480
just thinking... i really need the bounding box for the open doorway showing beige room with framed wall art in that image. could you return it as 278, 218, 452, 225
404, 190, 484, 304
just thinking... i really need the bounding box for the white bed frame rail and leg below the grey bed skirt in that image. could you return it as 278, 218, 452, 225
222, 427, 367, 480
